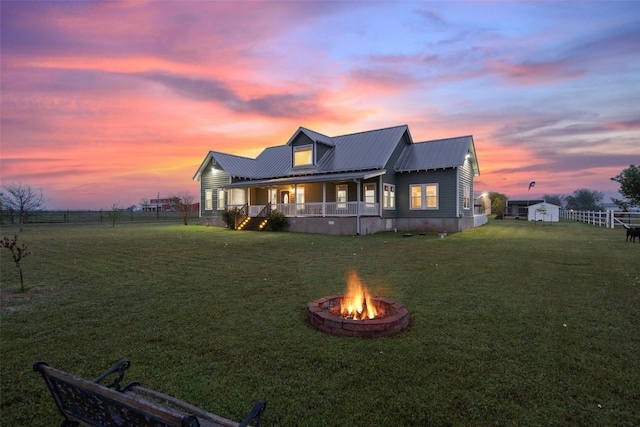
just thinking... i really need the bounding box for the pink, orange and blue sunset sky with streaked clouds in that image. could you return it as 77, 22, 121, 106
0, 0, 640, 209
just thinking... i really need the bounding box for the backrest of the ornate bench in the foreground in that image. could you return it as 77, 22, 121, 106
34, 362, 200, 427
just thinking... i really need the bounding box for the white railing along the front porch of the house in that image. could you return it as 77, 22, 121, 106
244, 202, 380, 217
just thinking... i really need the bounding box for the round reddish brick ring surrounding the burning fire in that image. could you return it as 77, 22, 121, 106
307, 295, 409, 338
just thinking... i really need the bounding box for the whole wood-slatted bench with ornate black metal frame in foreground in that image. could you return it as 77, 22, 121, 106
33, 359, 266, 427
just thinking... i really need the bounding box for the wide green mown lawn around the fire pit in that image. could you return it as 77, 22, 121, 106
0, 221, 640, 427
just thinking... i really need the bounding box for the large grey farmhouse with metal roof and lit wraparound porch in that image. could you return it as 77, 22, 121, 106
194, 125, 486, 234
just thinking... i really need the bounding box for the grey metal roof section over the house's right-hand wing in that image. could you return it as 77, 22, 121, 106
395, 135, 480, 175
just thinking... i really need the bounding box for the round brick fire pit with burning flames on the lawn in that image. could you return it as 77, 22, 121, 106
307, 271, 409, 338
